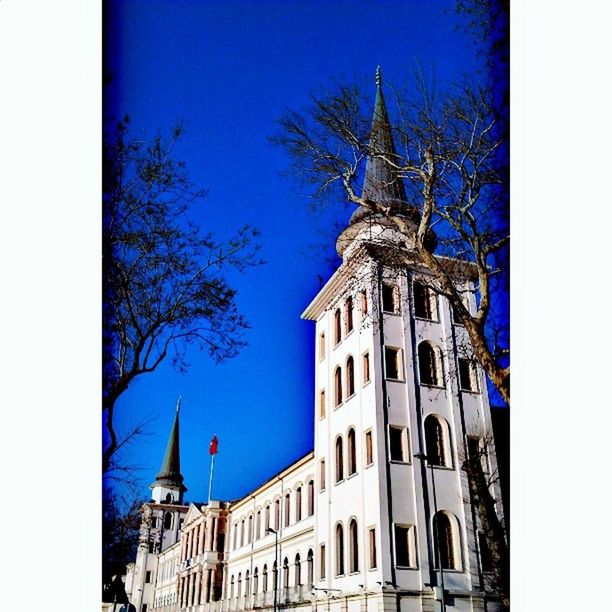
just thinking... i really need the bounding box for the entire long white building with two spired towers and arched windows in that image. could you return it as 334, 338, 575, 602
125, 73, 501, 612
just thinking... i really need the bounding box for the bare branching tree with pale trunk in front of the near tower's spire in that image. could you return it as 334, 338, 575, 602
273, 76, 510, 402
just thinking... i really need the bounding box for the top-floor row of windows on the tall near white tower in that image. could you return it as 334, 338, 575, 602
319, 281, 468, 360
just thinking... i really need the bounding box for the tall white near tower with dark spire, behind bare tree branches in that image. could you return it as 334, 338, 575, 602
303, 70, 501, 612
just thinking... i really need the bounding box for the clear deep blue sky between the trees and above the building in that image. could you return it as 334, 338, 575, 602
105, 0, 488, 501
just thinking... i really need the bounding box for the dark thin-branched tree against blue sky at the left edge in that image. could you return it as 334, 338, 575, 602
103, 118, 262, 472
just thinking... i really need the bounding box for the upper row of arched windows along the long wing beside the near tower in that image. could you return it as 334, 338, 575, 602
233, 480, 314, 550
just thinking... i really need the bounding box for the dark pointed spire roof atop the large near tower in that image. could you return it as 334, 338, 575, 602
362, 66, 406, 205
